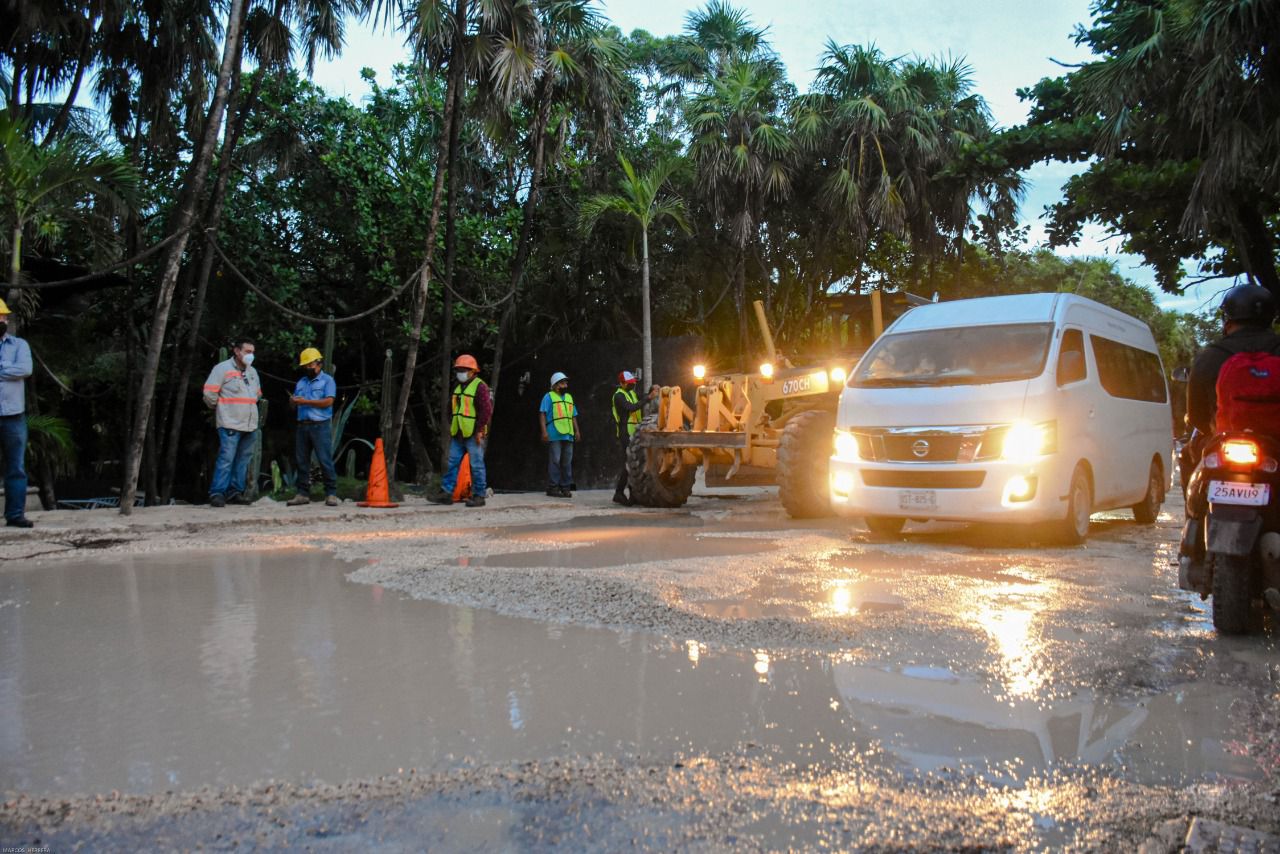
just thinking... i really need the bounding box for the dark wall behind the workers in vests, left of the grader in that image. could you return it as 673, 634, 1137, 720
485, 337, 703, 490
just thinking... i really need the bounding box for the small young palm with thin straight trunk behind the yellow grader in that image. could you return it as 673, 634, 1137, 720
579, 154, 691, 384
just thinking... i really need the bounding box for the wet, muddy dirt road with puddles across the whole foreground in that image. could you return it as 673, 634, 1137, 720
0, 492, 1280, 850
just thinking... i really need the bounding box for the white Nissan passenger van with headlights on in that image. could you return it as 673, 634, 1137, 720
829, 293, 1172, 543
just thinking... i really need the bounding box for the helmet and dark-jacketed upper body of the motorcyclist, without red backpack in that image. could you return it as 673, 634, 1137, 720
1187, 284, 1280, 435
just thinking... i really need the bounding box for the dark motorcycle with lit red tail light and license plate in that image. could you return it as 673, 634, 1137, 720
1178, 431, 1280, 635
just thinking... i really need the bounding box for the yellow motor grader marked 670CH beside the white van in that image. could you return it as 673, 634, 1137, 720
627, 291, 925, 519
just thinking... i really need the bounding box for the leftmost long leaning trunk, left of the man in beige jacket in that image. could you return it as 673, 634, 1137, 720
120, 0, 247, 516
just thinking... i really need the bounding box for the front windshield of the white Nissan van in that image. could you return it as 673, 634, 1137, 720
849, 323, 1053, 388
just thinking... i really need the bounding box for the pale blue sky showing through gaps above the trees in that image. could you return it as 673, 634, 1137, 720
315, 0, 1229, 311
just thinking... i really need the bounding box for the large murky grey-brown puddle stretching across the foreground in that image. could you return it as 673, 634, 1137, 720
0, 547, 1258, 794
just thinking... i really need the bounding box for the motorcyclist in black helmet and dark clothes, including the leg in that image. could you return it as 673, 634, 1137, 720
1179, 284, 1280, 591
